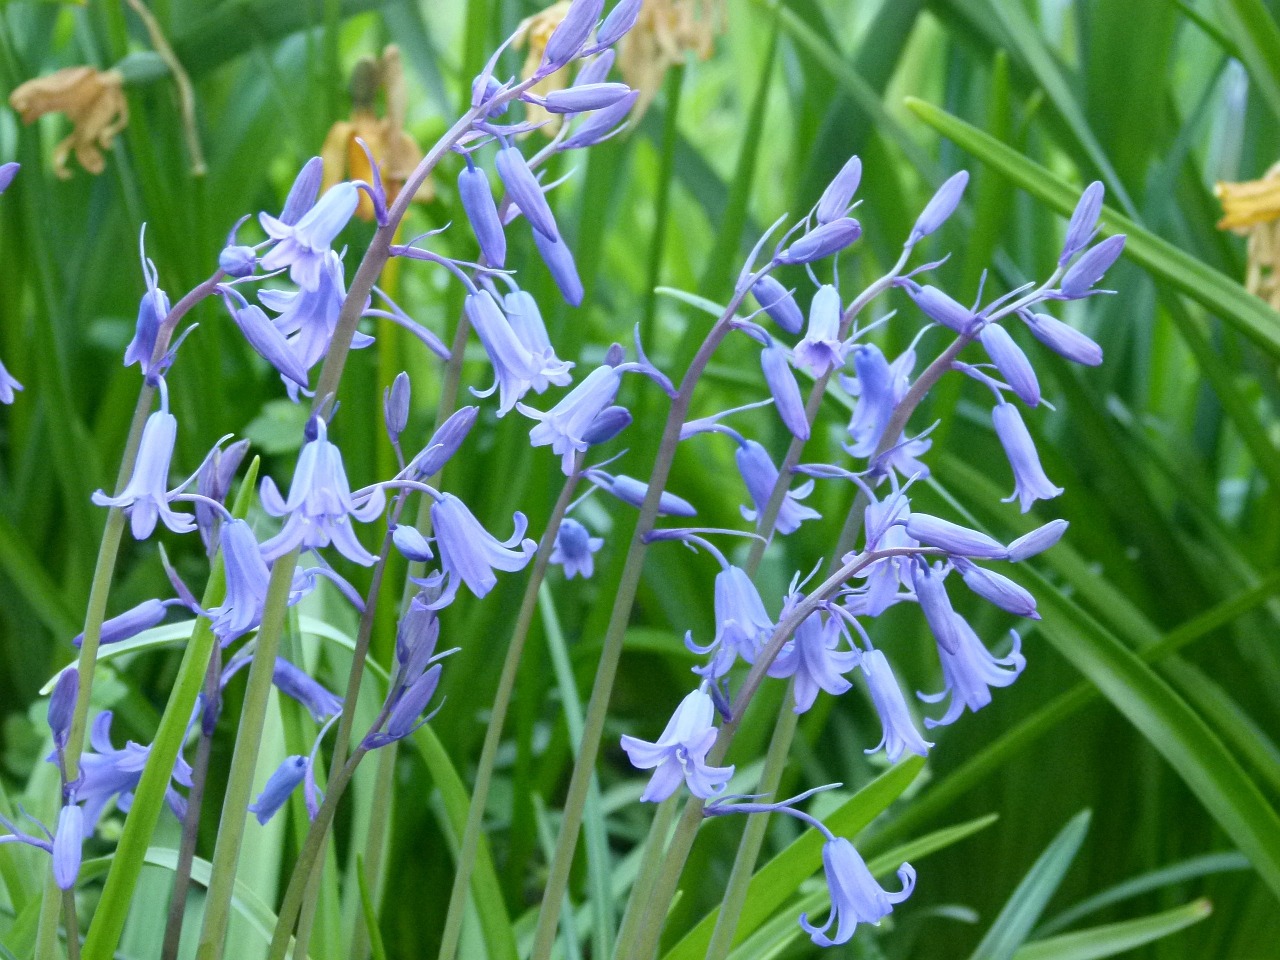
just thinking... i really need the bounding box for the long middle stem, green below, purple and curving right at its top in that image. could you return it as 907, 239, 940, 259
530, 275, 755, 960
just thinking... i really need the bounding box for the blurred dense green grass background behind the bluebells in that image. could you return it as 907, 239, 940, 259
0, 0, 1280, 960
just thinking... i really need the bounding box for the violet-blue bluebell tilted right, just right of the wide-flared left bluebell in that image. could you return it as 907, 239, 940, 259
431, 493, 538, 608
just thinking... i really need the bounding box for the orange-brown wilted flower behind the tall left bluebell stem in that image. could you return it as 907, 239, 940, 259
320, 44, 433, 220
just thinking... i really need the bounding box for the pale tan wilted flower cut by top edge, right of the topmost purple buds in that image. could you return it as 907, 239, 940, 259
618, 0, 726, 118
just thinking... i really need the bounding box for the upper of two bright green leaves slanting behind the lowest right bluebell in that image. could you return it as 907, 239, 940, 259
664, 756, 924, 960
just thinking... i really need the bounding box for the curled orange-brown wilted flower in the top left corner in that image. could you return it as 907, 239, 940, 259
9, 67, 129, 179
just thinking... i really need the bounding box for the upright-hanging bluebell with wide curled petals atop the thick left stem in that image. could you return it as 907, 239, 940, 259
260, 417, 387, 567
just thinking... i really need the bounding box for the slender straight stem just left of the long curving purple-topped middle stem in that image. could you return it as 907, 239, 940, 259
440, 463, 582, 960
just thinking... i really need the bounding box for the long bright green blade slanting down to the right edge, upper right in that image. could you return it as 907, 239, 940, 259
906, 97, 1280, 358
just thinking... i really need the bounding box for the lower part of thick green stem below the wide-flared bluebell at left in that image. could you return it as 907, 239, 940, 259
196, 549, 298, 960
